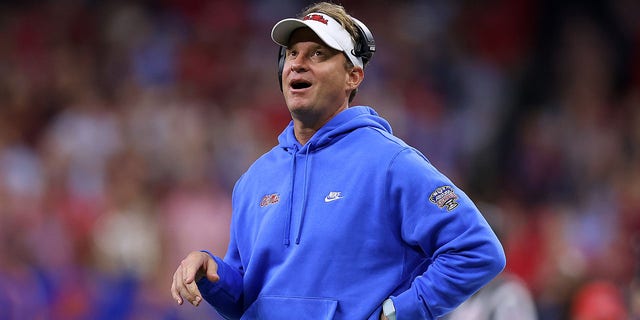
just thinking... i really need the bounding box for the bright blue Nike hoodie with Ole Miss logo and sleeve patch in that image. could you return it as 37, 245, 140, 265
198, 107, 505, 320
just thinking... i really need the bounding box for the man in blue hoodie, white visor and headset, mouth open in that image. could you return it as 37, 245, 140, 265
171, 3, 505, 320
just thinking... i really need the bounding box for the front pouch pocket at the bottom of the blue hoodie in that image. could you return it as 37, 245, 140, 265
242, 296, 338, 320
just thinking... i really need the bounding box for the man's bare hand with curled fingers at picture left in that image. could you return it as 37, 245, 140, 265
171, 251, 220, 307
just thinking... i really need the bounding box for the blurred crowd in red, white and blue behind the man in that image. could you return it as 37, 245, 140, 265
0, 0, 640, 320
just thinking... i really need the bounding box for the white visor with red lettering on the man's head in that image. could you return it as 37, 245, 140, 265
271, 13, 363, 68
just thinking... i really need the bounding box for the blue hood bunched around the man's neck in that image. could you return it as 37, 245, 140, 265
278, 106, 392, 153
